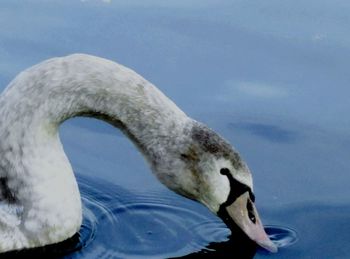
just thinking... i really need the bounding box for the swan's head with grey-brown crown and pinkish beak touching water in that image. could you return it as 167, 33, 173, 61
152, 122, 277, 252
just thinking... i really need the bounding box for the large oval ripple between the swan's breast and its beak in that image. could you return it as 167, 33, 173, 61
87, 201, 229, 258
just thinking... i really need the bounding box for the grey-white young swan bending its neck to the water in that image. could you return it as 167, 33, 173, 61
0, 54, 277, 253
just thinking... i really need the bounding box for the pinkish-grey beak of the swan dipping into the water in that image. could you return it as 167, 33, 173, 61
218, 192, 277, 253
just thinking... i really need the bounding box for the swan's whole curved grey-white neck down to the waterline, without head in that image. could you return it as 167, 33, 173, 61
0, 55, 189, 252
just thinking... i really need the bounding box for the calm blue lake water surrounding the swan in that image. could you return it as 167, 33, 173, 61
0, 0, 350, 258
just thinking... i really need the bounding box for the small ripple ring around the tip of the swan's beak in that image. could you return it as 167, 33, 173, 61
265, 226, 298, 248
